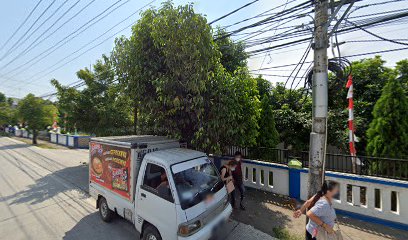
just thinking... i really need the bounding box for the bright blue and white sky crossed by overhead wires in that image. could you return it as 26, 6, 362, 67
0, 0, 408, 98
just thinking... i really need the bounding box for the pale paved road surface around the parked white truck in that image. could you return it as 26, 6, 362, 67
0, 137, 273, 240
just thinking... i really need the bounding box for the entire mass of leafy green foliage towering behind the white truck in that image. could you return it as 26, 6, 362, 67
111, 2, 259, 151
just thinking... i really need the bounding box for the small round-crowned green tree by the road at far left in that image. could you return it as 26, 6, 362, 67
18, 94, 58, 144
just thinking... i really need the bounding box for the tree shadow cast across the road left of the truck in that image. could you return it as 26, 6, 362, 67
2, 165, 89, 204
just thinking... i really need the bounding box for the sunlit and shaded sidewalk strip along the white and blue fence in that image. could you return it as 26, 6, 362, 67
233, 188, 408, 240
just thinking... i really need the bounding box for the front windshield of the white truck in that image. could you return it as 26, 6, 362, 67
172, 158, 224, 209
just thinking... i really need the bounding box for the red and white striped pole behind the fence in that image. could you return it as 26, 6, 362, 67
346, 74, 357, 173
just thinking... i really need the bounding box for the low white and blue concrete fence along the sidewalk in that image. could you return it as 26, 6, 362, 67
214, 157, 408, 230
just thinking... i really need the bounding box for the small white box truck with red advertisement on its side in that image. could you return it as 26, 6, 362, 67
89, 136, 232, 240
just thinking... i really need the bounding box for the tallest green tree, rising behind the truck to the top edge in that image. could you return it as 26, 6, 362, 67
112, 1, 219, 142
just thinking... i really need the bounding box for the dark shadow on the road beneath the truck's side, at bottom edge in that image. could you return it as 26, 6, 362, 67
63, 212, 139, 240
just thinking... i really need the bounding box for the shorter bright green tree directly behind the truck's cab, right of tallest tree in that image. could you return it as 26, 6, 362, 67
194, 64, 260, 153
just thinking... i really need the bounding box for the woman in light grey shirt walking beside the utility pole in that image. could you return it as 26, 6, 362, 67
293, 181, 339, 240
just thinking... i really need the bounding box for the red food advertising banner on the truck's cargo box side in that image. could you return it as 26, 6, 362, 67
89, 142, 131, 199
